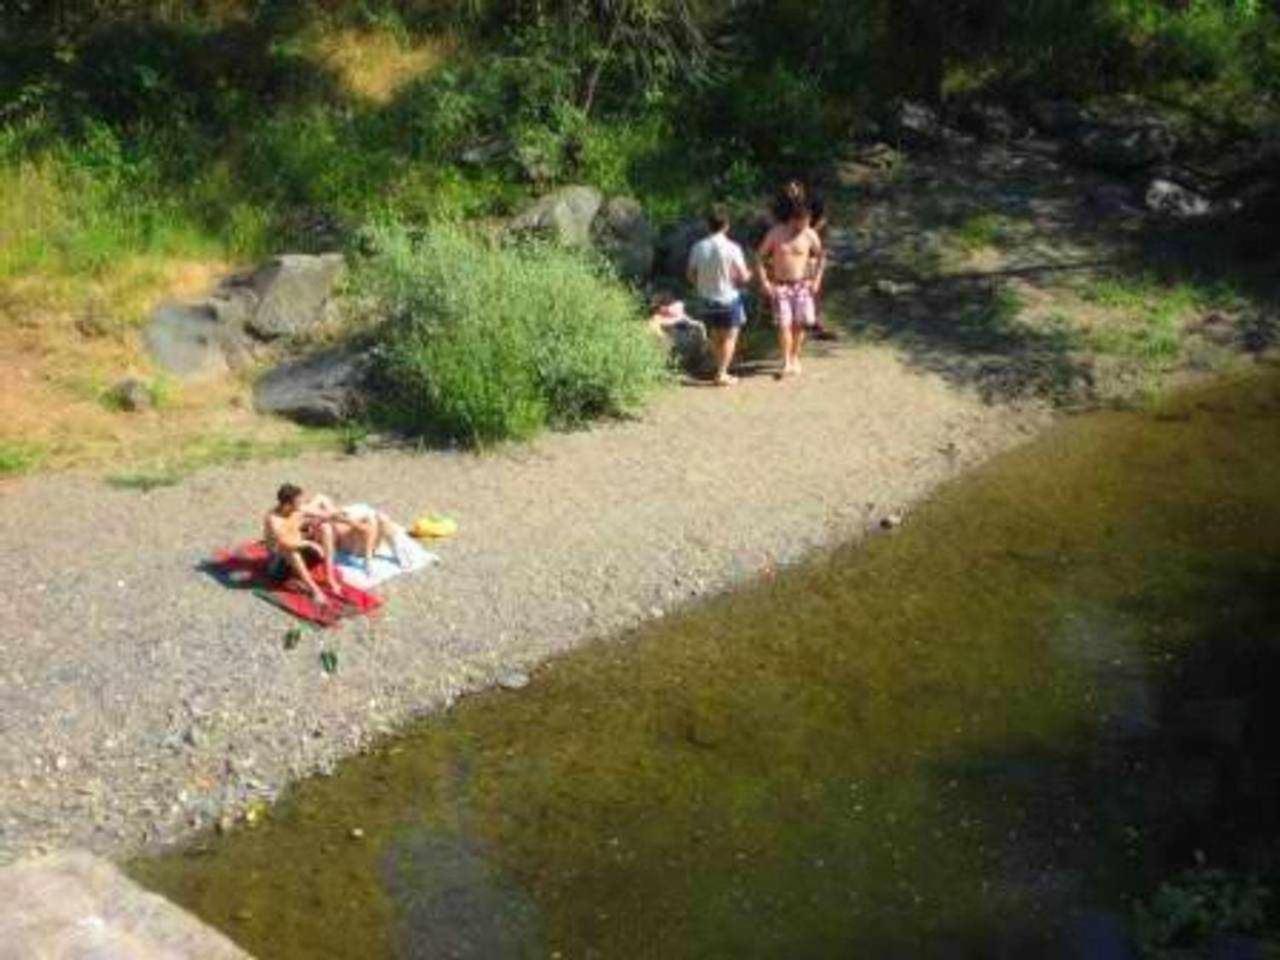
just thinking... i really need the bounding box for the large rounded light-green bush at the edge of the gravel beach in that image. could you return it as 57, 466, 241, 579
352, 224, 664, 445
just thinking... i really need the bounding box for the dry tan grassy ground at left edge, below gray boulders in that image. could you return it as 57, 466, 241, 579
0, 256, 340, 470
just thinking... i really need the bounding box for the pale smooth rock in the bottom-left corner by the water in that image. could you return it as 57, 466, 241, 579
0, 852, 250, 960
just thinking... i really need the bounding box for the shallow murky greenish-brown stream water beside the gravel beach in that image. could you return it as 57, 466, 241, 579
131, 370, 1280, 960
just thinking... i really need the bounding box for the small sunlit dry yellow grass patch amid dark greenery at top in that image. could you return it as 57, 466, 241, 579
305, 29, 457, 104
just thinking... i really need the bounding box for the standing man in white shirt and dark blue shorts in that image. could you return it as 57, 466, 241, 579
689, 207, 751, 387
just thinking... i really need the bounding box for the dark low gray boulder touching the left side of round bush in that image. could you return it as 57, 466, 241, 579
253, 347, 370, 426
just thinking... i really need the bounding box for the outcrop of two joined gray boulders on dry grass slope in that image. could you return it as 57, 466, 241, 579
143, 253, 343, 380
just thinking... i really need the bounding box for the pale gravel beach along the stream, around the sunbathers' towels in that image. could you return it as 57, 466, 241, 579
0, 346, 1048, 860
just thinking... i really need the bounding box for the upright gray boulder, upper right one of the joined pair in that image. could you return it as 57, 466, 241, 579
246, 253, 346, 340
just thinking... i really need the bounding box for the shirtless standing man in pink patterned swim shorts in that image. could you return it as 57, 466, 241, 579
756, 193, 826, 376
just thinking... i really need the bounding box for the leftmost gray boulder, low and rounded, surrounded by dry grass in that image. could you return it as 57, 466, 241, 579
142, 302, 253, 380
